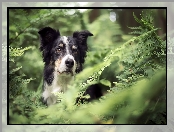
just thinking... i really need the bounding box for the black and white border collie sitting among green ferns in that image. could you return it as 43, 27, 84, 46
38, 27, 100, 106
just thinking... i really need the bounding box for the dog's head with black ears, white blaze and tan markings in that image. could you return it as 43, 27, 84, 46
38, 27, 93, 75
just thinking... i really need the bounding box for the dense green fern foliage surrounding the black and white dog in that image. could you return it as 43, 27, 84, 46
8, 9, 166, 124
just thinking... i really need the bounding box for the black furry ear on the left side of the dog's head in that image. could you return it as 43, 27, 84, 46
38, 27, 60, 51
